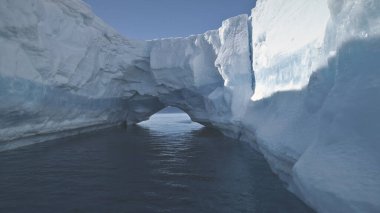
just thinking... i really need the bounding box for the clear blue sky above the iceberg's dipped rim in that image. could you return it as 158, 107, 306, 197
84, 0, 256, 39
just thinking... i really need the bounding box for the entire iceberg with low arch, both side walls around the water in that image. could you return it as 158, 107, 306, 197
0, 0, 380, 212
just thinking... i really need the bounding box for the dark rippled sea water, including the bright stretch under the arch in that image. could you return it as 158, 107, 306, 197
0, 114, 311, 213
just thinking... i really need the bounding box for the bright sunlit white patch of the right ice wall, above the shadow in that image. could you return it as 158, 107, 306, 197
252, 0, 329, 100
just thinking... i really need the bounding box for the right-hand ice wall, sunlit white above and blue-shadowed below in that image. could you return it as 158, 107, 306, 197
242, 0, 380, 212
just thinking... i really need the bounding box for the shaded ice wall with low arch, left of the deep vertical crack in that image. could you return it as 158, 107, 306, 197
0, 0, 253, 149
